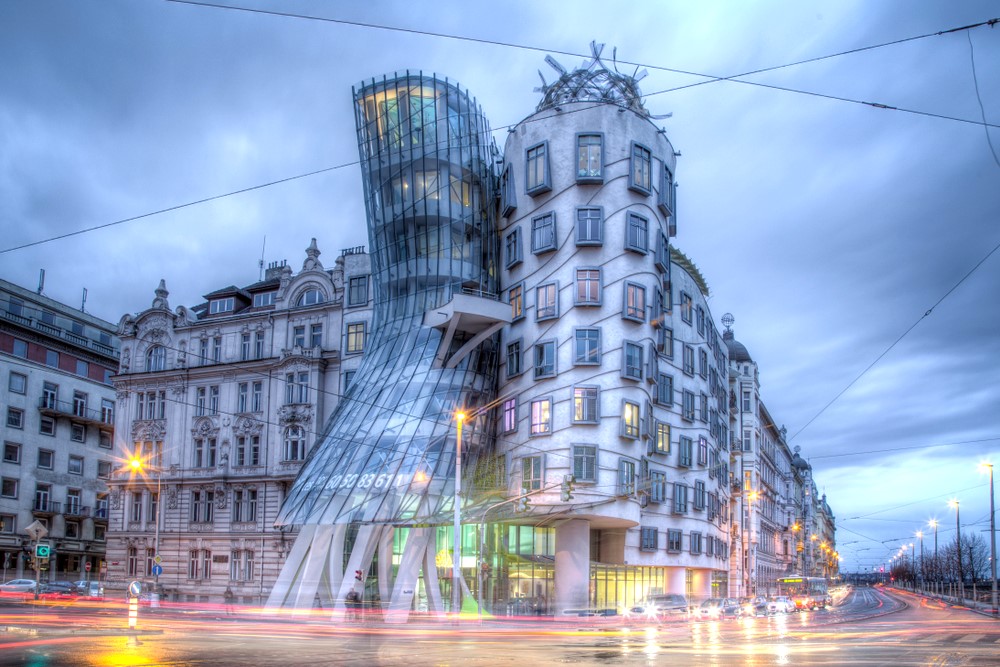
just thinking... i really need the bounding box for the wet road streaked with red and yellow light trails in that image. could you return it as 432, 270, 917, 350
0, 588, 1000, 667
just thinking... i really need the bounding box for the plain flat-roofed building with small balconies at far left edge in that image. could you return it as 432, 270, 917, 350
0, 280, 118, 581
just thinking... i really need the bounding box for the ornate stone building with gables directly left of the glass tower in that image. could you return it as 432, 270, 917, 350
108, 239, 371, 603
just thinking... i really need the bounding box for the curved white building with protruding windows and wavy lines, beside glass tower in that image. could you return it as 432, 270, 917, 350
498, 96, 729, 609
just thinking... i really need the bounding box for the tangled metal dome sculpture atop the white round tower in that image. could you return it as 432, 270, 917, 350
535, 42, 655, 118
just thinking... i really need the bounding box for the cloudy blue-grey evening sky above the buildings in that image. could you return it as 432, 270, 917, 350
0, 0, 1000, 571
